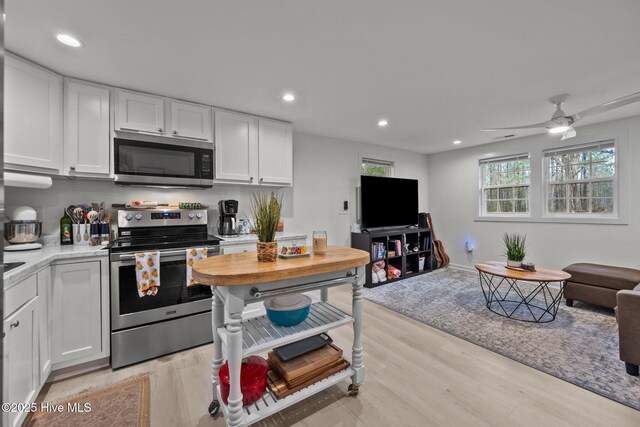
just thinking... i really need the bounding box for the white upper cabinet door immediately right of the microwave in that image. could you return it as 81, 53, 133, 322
215, 111, 258, 184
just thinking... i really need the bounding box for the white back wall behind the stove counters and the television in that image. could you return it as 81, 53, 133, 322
5, 133, 427, 246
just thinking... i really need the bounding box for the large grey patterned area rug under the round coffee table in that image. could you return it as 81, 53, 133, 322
364, 268, 640, 410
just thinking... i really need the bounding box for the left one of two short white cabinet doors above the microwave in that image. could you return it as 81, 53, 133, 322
115, 89, 165, 135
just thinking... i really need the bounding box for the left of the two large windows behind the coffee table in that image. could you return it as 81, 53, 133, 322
480, 154, 531, 216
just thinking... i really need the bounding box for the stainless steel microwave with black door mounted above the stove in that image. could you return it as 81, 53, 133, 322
113, 138, 213, 188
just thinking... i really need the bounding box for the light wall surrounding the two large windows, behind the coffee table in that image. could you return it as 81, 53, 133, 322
427, 117, 640, 268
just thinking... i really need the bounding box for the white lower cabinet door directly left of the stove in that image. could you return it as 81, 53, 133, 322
51, 261, 109, 369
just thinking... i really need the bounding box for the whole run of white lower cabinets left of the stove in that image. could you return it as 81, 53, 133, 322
2, 257, 109, 427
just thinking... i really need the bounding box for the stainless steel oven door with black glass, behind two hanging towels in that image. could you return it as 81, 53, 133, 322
111, 247, 219, 331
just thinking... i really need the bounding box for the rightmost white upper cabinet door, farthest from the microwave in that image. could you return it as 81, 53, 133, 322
258, 119, 293, 185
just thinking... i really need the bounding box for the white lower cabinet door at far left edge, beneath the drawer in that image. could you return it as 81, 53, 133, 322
2, 296, 40, 427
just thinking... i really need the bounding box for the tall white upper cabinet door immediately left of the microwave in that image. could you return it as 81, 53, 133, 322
63, 80, 111, 175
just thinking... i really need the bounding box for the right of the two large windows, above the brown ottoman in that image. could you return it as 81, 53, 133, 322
544, 140, 618, 216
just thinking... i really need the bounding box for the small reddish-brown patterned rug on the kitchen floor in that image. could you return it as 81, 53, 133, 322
24, 375, 150, 427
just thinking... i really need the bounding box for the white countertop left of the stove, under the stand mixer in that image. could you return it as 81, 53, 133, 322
3, 243, 109, 289
